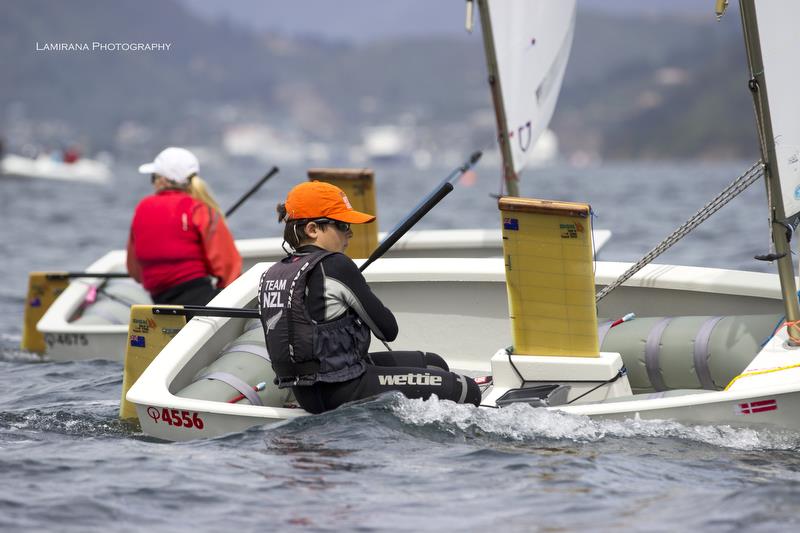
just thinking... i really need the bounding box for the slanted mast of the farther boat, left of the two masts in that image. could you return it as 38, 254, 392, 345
478, 0, 519, 196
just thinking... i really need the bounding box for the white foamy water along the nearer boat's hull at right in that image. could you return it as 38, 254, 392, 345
392, 396, 800, 450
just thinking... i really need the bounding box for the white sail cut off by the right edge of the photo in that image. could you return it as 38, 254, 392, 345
755, 0, 800, 218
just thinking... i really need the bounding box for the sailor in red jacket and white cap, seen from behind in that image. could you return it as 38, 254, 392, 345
127, 147, 242, 305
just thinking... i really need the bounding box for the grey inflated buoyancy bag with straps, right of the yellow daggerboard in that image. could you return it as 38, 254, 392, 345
599, 315, 781, 392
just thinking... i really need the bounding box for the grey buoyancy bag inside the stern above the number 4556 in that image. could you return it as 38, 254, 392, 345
176, 318, 293, 407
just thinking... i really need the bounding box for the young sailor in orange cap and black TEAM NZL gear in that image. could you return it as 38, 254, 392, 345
258, 181, 481, 413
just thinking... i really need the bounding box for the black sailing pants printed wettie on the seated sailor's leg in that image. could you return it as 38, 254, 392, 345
292, 351, 481, 414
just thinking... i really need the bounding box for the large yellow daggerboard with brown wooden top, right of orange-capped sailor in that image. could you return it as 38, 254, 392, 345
498, 197, 599, 357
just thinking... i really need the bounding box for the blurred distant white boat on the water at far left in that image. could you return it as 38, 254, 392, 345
0, 154, 111, 183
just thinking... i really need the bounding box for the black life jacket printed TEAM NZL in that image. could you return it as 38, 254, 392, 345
258, 247, 371, 388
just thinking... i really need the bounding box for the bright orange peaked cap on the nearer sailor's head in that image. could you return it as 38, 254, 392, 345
286, 181, 375, 224
